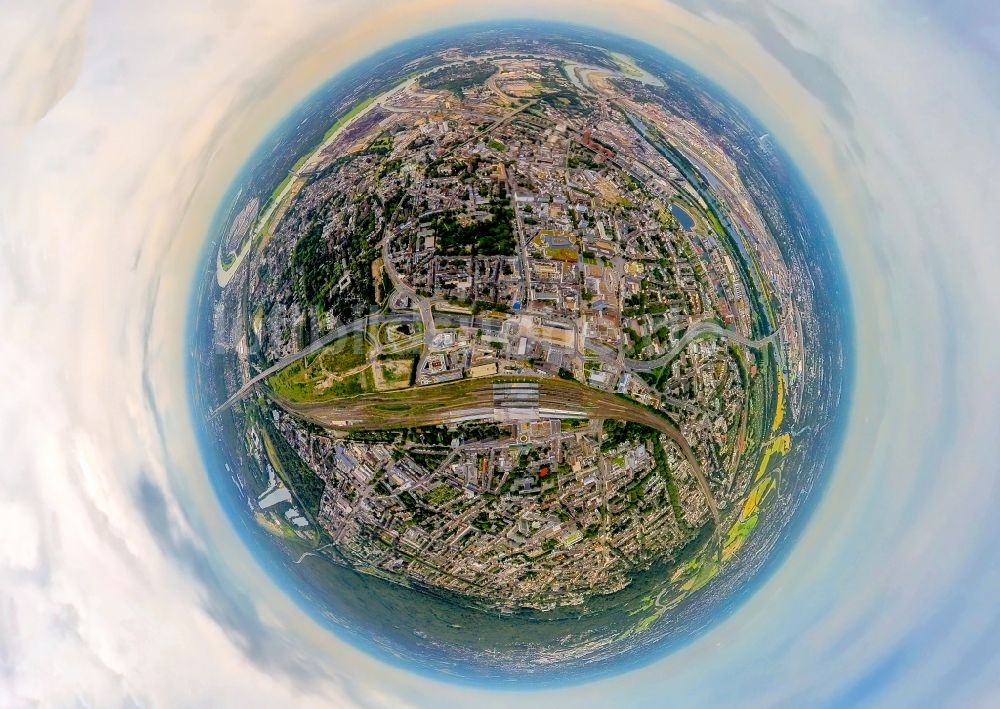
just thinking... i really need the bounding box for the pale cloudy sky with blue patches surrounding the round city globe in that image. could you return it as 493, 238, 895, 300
0, 0, 1000, 707
